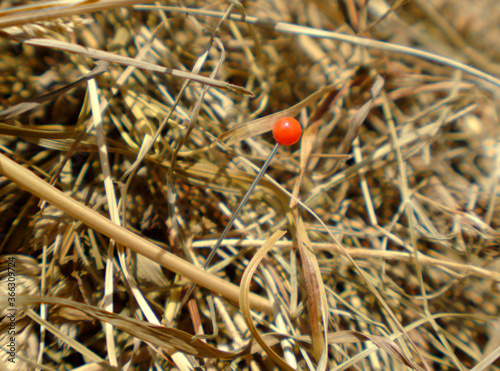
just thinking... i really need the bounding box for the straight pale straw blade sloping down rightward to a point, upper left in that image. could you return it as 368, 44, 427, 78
23, 38, 253, 96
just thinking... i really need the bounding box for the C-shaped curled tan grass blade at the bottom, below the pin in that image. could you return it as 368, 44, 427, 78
240, 230, 293, 371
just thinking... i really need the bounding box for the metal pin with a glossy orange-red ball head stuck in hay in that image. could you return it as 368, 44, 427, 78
181, 117, 302, 308
